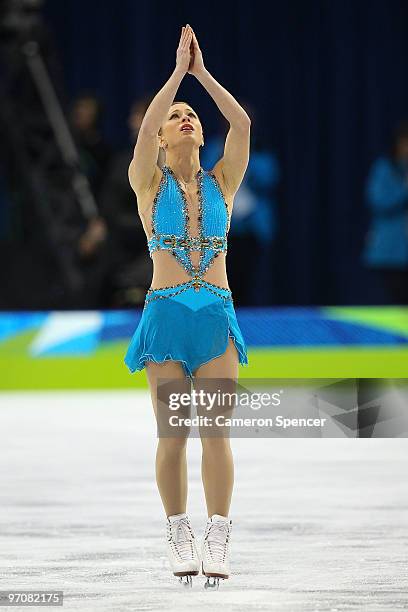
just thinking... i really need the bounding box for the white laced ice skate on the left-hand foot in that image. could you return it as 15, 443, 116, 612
167, 512, 200, 587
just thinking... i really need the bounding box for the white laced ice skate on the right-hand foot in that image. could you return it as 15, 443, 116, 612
202, 514, 232, 589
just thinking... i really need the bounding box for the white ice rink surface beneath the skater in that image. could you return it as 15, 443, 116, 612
0, 391, 408, 612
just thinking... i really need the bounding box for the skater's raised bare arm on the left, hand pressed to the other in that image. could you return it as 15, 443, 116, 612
129, 24, 192, 194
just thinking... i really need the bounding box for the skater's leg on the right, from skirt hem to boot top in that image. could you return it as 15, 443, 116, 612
194, 337, 239, 517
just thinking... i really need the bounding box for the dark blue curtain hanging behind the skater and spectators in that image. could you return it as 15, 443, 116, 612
45, 0, 408, 304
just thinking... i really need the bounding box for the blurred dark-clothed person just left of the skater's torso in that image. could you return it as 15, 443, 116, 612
101, 96, 152, 307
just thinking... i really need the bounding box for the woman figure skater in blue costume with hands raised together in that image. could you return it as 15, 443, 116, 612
125, 25, 251, 586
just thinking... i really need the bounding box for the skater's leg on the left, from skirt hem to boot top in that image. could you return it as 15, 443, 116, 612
146, 361, 191, 516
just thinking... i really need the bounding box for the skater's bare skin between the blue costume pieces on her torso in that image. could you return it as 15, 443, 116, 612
139, 171, 232, 290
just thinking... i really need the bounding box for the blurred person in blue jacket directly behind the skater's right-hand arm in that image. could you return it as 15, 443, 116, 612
201, 102, 280, 306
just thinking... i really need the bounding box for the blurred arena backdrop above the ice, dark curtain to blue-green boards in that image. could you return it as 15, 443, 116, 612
0, 0, 408, 388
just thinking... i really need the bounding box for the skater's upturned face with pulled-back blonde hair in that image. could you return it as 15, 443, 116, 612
159, 104, 204, 151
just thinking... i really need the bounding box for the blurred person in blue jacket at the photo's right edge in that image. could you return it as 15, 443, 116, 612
363, 121, 408, 304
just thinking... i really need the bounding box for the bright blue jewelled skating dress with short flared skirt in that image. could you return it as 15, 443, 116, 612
125, 165, 248, 379
